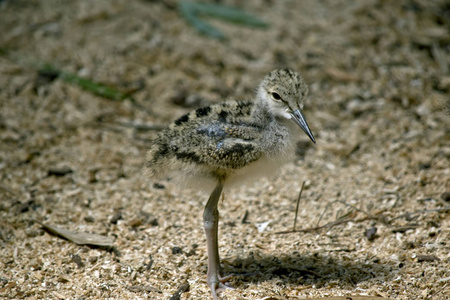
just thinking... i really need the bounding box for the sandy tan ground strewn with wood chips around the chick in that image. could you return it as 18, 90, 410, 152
0, 0, 450, 299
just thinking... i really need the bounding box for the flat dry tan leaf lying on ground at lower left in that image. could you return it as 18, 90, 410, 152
34, 220, 114, 247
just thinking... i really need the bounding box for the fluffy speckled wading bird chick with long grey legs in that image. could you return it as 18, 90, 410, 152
146, 69, 315, 299
